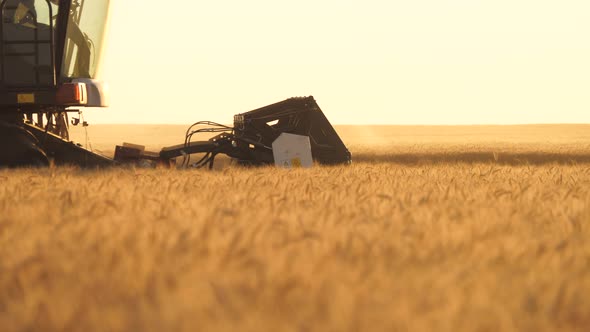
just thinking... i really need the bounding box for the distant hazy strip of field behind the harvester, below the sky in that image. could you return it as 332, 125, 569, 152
72, 125, 590, 164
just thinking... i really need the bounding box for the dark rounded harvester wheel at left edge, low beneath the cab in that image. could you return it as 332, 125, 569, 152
0, 122, 49, 167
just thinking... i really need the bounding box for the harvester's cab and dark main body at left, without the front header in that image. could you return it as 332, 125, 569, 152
0, 0, 111, 166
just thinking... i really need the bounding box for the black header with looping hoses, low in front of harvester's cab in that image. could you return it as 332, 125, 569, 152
115, 96, 351, 167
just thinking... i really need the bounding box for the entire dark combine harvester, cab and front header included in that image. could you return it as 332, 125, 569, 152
0, 0, 351, 167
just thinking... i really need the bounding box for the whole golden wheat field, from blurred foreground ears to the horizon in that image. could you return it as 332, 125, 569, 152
0, 126, 590, 331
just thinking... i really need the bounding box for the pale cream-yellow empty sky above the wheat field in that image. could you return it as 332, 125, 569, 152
91, 0, 590, 124
